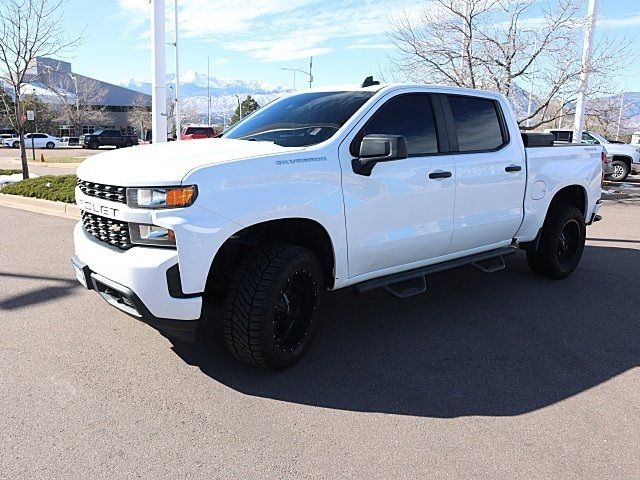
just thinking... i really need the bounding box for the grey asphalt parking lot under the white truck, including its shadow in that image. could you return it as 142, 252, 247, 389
0, 182, 640, 479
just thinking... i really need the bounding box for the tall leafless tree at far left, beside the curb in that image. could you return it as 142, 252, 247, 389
0, 0, 81, 178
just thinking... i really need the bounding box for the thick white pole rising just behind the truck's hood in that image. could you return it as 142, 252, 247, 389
150, 0, 167, 143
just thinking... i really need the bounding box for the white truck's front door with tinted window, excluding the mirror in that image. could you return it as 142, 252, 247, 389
340, 93, 455, 278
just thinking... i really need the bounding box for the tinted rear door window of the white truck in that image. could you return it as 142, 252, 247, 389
449, 95, 505, 152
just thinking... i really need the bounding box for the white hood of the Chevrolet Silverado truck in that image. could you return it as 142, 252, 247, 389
77, 138, 304, 187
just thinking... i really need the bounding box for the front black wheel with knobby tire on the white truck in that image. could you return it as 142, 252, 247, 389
223, 243, 324, 370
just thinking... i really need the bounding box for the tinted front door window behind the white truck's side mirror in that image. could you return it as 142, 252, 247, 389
351, 94, 438, 156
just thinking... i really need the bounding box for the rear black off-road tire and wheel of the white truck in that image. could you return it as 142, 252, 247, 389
527, 204, 586, 279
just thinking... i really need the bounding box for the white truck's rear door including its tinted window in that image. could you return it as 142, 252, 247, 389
445, 95, 527, 253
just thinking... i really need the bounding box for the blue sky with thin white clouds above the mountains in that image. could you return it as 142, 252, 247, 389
56, 0, 640, 91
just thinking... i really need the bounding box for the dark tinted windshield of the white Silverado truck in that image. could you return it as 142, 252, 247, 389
223, 91, 375, 147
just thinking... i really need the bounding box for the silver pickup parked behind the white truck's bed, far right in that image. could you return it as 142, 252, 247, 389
545, 128, 640, 182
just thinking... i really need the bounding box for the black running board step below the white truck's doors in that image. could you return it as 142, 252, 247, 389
353, 247, 517, 298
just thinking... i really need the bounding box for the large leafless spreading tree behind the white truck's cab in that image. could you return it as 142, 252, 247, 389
390, 0, 629, 129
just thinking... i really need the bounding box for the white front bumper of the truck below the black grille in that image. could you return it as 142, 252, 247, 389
72, 224, 202, 340
